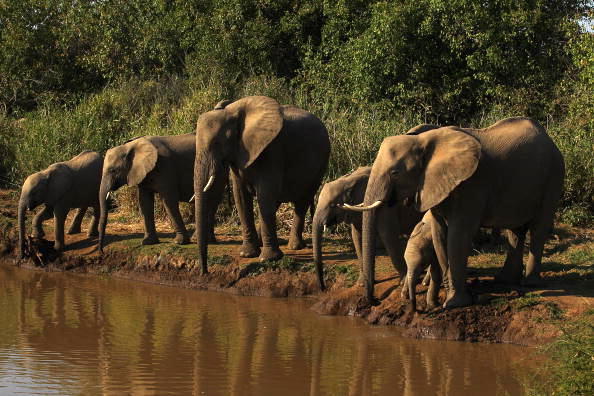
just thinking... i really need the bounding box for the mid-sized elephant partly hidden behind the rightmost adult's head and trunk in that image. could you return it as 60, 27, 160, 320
312, 166, 422, 290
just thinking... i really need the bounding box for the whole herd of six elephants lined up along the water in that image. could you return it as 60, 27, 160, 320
18, 96, 565, 309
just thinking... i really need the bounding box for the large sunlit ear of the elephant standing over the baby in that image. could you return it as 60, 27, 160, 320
415, 127, 481, 212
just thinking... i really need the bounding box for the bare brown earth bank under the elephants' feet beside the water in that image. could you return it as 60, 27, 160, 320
0, 191, 594, 345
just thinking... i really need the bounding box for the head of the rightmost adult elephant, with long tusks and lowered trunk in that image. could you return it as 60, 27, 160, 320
349, 127, 481, 301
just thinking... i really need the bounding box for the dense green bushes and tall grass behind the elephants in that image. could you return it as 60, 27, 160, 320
0, 0, 594, 222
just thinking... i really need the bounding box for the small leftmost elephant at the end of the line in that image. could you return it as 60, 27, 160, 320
18, 151, 103, 258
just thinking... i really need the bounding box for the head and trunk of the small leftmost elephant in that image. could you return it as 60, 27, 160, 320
18, 163, 72, 258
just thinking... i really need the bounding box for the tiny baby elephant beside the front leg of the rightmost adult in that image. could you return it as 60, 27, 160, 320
403, 211, 442, 312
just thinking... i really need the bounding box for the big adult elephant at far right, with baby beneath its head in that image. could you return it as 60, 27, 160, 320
346, 117, 565, 308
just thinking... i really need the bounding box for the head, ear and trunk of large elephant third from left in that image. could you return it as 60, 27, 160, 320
194, 96, 283, 273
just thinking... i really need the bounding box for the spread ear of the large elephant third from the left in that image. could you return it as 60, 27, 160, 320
226, 96, 283, 169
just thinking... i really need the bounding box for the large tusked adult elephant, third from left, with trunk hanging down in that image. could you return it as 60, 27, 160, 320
194, 96, 330, 273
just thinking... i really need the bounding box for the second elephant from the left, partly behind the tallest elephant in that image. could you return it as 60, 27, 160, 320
98, 133, 227, 252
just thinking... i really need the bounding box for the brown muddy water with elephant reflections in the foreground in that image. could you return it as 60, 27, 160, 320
0, 265, 533, 396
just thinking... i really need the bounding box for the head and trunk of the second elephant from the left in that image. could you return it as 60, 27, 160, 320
99, 137, 158, 251
